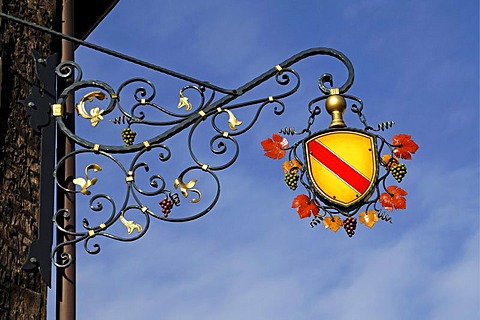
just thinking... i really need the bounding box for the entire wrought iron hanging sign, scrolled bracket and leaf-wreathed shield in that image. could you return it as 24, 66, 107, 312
8, 13, 418, 284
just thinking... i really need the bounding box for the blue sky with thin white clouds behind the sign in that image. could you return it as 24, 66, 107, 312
49, 0, 480, 320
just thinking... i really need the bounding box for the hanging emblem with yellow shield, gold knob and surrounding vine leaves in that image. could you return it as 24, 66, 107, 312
262, 89, 418, 237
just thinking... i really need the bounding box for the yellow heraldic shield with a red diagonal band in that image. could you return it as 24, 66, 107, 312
304, 129, 378, 210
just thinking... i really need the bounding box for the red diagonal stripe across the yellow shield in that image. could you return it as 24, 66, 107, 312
308, 140, 370, 194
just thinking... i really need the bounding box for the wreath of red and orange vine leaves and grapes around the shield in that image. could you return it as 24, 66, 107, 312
261, 130, 419, 237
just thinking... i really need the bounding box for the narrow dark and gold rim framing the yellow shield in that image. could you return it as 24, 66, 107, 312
303, 128, 379, 211
